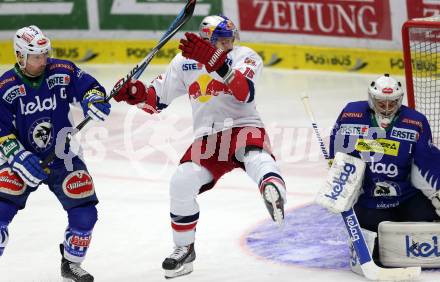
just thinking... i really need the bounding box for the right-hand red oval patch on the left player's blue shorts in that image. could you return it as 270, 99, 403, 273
63, 170, 95, 199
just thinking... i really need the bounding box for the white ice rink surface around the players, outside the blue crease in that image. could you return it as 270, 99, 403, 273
0, 65, 440, 282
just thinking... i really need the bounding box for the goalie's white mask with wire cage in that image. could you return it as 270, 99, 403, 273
368, 73, 404, 118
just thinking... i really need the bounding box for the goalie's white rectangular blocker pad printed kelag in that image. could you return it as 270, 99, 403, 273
315, 152, 365, 213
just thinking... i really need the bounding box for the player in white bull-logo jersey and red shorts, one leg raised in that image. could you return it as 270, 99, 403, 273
115, 16, 286, 278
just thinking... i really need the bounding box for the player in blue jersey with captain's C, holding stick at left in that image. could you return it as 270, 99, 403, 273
0, 26, 110, 281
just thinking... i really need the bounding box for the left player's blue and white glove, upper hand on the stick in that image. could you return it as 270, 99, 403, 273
81, 89, 111, 121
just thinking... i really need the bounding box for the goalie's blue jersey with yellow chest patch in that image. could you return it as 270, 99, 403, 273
330, 101, 440, 209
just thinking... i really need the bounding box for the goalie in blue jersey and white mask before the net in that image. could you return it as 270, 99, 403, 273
330, 74, 440, 266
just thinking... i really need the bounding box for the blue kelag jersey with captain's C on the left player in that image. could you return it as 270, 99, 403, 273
0, 59, 105, 166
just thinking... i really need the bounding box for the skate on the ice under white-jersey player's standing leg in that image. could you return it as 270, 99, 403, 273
162, 243, 196, 279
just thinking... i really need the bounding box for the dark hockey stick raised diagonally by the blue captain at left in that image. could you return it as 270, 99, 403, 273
41, 0, 197, 168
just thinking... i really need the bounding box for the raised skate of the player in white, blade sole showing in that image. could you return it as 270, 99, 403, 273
262, 182, 284, 226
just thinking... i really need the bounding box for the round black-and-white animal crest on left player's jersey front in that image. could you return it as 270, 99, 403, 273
28, 118, 54, 152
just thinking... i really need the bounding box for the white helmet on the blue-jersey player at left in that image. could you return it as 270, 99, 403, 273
14, 25, 51, 68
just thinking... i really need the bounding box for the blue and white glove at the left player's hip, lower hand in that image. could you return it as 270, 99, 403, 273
0, 138, 48, 187
